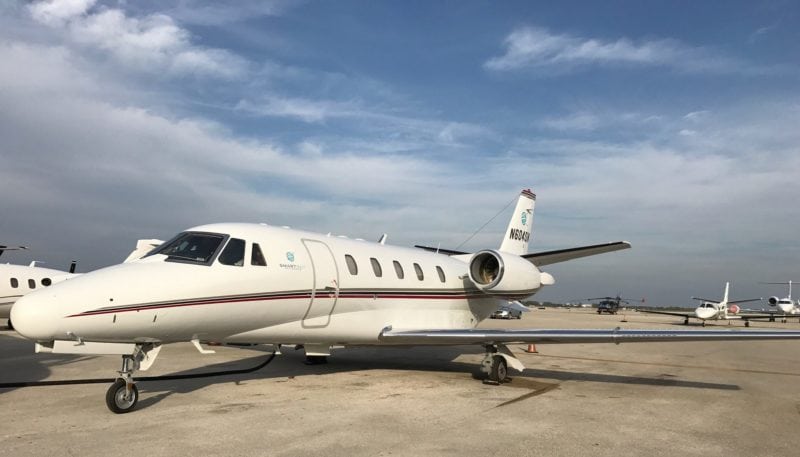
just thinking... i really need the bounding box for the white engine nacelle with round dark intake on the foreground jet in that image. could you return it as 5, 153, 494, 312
469, 250, 552, 298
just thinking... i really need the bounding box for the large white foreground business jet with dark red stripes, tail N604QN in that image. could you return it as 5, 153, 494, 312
11, 190, 800, 413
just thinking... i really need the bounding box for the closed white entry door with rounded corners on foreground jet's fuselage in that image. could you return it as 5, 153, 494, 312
302, 239, 339, 327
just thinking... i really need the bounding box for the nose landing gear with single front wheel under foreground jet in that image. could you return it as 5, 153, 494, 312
106, 344, 161, 414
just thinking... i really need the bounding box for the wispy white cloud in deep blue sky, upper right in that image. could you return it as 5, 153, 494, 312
484, 27, 749, 73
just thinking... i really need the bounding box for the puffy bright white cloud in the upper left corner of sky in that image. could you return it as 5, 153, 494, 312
29, 0, 248, 78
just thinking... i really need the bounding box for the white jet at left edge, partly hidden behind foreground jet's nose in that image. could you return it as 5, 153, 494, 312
0, 240, 163, 330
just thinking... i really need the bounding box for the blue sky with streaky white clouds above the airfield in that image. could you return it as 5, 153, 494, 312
0, 0, 800, 304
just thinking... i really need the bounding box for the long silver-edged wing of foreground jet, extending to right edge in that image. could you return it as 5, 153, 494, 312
379, 327, 800, 345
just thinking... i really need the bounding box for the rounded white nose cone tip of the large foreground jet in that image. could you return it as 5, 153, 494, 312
11, 290, 61, 341
